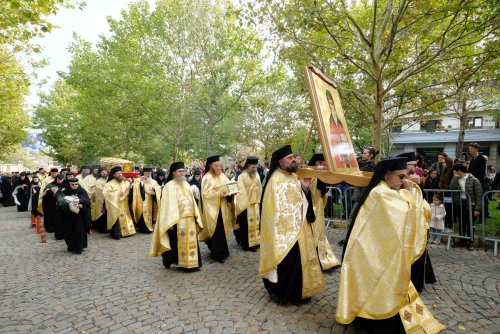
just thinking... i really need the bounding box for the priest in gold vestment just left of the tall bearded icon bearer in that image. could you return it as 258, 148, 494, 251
234, 156, 262, 252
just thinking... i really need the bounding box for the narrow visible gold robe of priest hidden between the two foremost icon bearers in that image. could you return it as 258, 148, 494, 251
310, 178, 340, 270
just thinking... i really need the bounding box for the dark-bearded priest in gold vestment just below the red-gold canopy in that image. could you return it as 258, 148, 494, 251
102, 166, 135, 240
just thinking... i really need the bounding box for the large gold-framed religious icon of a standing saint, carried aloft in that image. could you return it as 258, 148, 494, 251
306, 67, 359, 174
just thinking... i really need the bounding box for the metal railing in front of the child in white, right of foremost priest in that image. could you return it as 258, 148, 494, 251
423, 189, 477, 250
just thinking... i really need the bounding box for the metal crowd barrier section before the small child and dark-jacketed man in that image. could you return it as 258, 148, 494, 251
423, 189, 476, 250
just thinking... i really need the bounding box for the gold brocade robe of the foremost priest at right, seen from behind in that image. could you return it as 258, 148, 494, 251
336, 181, 444, 333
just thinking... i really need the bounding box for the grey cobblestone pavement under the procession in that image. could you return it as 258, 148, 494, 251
0, 206, 500, 333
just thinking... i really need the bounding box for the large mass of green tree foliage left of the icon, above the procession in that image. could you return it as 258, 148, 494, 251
36, 0, 304, 164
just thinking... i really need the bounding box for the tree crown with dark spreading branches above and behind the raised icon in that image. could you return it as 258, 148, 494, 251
247, 0, 498, 157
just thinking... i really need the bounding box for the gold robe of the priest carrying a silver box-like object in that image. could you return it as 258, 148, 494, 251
200, 172, 235, 241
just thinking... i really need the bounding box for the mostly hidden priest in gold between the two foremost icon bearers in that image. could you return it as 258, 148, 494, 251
309, 153, 340, 271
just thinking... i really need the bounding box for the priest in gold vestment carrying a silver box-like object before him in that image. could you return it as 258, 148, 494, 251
200, 156, 235, 263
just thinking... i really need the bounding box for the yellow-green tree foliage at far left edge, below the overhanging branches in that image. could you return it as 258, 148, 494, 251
0, 46, 29, 159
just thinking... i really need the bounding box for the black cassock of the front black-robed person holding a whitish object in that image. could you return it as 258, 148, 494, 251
57, 185, 90, 254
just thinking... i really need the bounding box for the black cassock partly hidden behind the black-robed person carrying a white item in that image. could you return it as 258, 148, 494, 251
42, 180, 68, 236
